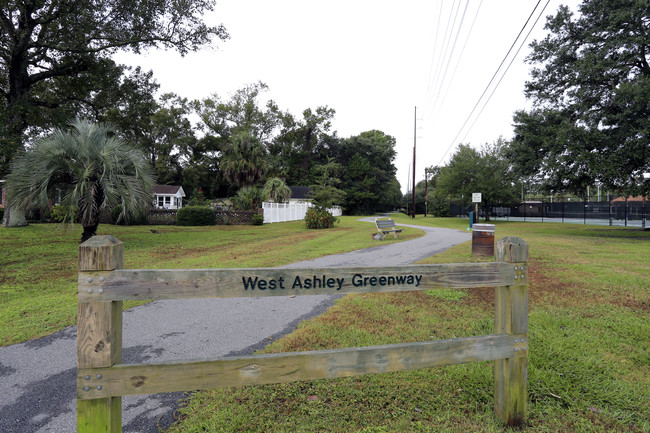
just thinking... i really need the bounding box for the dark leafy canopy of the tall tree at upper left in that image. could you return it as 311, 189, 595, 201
0, 0, 228, 176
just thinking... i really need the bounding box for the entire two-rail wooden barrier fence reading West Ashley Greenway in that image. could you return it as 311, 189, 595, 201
77, 236, 528, 433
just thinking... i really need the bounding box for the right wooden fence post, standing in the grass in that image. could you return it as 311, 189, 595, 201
494, 236, 528, 426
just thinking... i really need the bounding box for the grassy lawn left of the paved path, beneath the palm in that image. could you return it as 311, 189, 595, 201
0, 217, 422, 346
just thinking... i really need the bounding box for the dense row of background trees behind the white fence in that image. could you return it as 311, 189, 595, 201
96, 79, 401, 214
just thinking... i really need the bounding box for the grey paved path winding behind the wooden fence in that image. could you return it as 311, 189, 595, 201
0, 219, 471, 433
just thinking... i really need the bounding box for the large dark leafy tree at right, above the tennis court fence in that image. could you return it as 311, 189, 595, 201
509, 0, 650, 195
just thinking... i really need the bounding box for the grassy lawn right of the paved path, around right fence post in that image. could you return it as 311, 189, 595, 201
169, 215, 650, 433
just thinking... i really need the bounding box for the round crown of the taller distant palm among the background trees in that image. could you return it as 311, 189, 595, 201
221, 132, 267, 187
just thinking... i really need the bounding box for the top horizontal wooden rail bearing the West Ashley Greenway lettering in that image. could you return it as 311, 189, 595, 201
79, 263, 526, 302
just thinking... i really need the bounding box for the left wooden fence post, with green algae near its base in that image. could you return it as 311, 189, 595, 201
77, 236, 124, 433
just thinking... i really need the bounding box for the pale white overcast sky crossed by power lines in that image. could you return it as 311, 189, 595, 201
116, 0, 580, 191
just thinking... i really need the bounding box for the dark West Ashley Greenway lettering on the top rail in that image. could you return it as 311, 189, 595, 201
242, 274, 422, 290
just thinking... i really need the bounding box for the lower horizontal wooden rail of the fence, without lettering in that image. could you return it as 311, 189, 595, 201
77, 335, 525, 399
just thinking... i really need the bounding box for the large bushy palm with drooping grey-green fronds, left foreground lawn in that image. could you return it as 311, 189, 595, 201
7, 119, 155, 242
